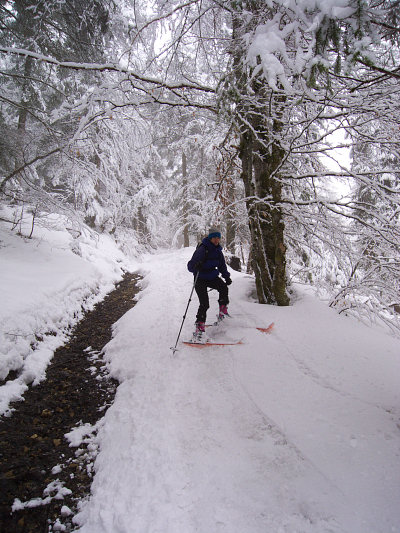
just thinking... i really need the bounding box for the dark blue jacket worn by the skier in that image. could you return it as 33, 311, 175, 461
188, 237, 231, 281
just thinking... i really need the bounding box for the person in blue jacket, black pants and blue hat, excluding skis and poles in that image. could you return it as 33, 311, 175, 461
187, 228, 232, 340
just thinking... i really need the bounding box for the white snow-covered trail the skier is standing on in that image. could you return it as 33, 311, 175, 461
76, 249, 400, 533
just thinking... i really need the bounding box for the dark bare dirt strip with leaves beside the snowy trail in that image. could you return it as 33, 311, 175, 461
0, 273, 140, 533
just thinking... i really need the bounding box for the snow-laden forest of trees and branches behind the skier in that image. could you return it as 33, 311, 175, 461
0, 0, 400, 332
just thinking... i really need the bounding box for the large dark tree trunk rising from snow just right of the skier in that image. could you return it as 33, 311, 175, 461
231, 2, 289, 305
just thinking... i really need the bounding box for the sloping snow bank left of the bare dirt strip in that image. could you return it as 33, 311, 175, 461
0, 208, 135, 414
